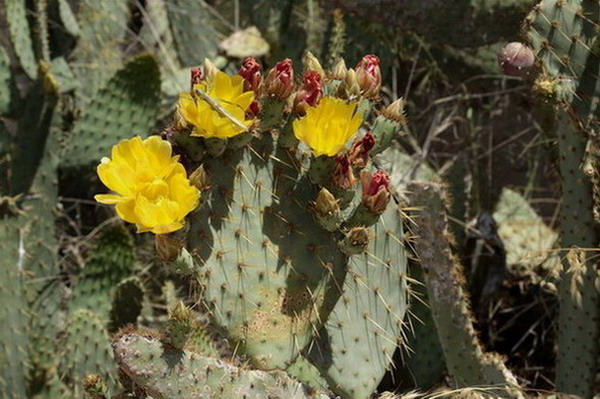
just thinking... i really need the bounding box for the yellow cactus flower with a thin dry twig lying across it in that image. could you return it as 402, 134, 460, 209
178, 71, 254, 139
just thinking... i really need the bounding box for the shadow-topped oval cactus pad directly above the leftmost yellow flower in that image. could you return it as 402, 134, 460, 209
61, 55, 160, 167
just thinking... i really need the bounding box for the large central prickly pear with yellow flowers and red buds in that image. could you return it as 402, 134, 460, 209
97, 54, 407, 398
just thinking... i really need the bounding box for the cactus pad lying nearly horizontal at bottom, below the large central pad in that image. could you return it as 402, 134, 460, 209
113, 333, 327, 399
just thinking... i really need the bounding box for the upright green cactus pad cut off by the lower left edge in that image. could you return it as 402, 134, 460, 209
0, 217, 28, 399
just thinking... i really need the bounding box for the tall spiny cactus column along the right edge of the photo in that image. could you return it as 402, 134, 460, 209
525, 0, 600, 398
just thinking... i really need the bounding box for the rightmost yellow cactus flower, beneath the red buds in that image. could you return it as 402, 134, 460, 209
293, 97, 362, 157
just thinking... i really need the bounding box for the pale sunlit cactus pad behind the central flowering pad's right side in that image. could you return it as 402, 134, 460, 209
309, 205, 407, 399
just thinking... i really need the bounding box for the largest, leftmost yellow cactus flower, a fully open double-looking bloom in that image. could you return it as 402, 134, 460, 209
95, 136, 200, 234
